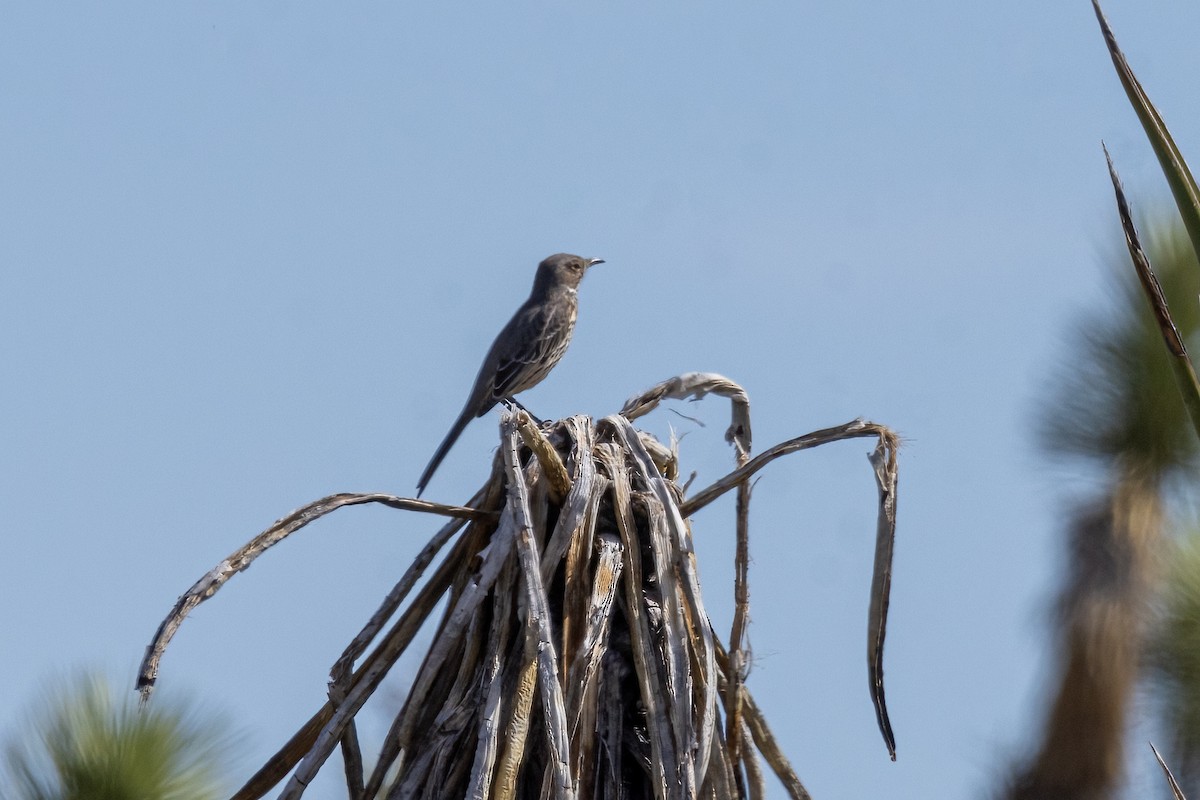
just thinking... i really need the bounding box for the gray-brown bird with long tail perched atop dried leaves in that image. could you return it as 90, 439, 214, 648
416, 253, 604, 497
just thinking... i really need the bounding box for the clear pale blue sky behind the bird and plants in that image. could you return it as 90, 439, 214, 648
0, 0, 1200, 799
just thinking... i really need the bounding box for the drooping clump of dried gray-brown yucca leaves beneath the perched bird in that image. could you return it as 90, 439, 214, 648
142, 373, 896, 800
